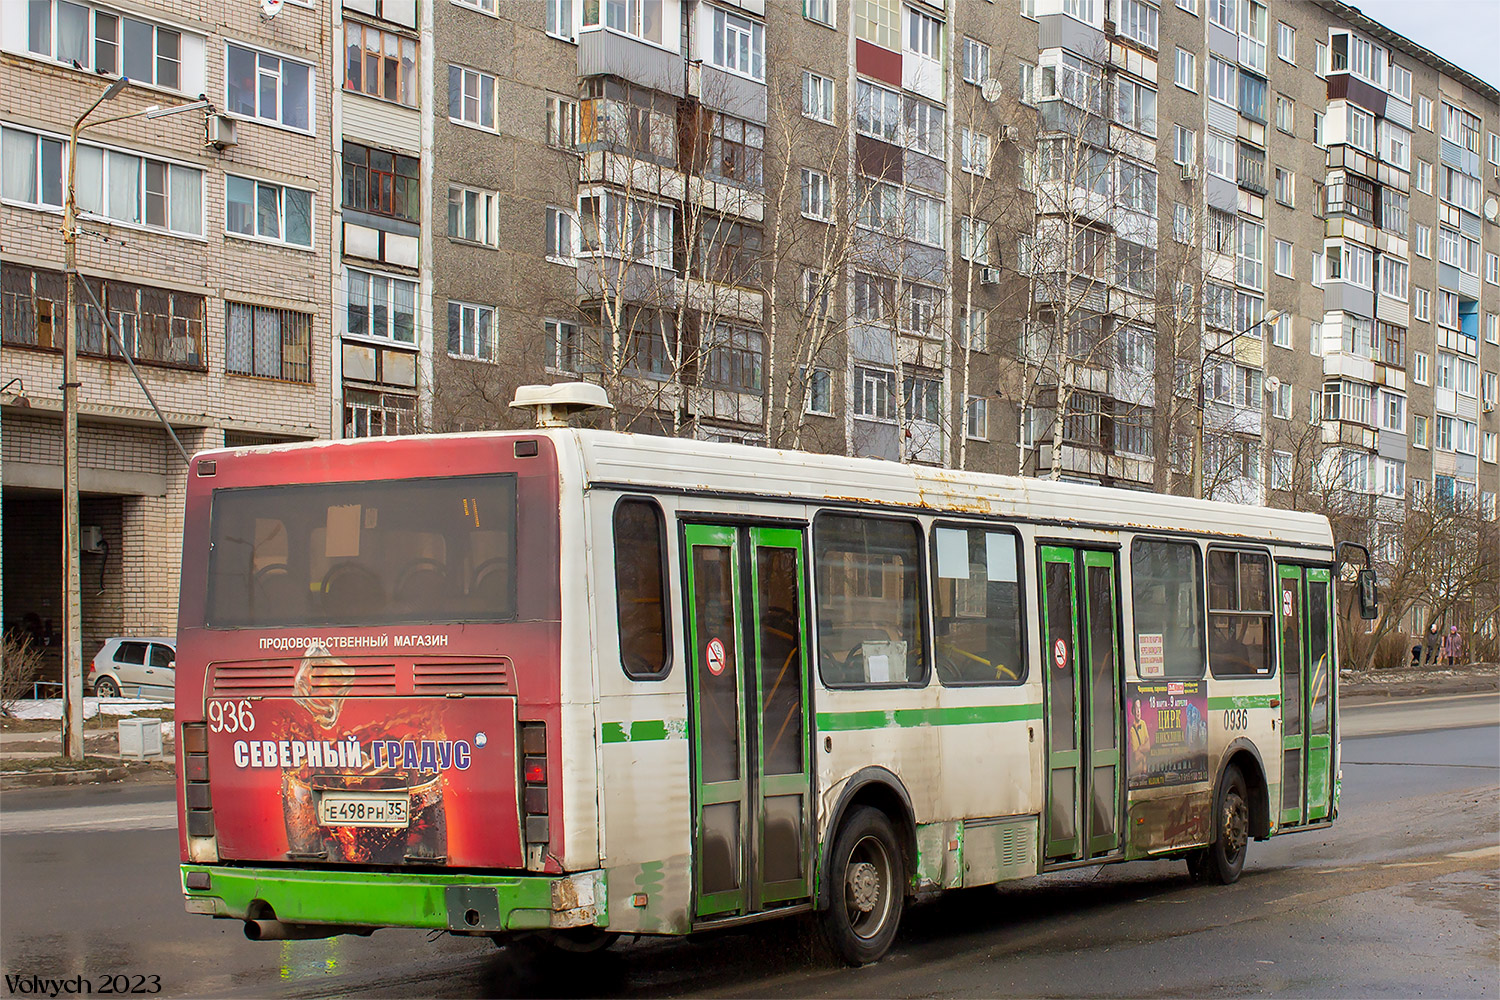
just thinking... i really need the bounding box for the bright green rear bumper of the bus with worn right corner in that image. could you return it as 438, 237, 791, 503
182, 865, 609, 934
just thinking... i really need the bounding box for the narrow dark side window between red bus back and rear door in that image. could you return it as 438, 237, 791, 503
615, 499, 669, 681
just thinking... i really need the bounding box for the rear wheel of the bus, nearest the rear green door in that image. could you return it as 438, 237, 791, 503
822, 805, 906, 966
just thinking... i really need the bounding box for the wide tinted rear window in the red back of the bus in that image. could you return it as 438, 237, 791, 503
207, 475, 518, 628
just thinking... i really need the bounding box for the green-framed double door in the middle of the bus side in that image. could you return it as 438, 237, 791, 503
1041, 546, 1124, 862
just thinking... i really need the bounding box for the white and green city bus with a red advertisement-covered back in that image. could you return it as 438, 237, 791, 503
177, 384, 1364, 964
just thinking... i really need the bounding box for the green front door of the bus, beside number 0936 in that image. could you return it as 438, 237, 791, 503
1277, 565, 1338, 826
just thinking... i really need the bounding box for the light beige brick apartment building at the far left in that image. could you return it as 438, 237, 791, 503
0, 0, 333, 670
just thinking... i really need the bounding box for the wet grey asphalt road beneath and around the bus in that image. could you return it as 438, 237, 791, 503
0, 694, 1500, 997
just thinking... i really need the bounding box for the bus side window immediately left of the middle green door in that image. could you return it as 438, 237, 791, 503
932, 525, 1026, 685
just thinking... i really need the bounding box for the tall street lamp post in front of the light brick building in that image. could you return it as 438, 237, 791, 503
63, 76, 209, 760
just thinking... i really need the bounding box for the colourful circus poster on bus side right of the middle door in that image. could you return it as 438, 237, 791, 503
1125, 681, 1209, 789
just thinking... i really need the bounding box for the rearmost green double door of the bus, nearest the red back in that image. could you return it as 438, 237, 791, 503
684, 525, 812, 918
